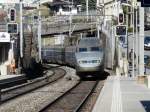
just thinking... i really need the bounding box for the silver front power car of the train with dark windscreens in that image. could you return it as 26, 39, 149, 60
75, 37, 104, 73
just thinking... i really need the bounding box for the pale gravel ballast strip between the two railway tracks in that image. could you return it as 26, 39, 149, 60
0, 67, 78, 112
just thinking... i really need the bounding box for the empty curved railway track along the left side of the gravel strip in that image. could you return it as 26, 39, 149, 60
0, 68, 66, 103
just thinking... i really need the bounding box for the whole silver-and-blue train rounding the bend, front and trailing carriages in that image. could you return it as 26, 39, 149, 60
42, 37, 105, 76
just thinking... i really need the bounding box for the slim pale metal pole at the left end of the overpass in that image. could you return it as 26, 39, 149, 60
38, 4, 41, 61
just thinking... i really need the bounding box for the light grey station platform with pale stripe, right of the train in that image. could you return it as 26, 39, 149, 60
92, 76, 150, 112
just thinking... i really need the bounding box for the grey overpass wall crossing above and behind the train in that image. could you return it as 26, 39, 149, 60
42, 12, 97, 35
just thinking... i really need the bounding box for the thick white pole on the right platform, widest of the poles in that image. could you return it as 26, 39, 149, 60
139, 1, 144, 75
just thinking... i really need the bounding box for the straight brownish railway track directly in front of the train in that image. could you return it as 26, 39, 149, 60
40, 81, 98, 112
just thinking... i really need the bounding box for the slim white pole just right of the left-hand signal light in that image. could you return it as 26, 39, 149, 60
19, 0, 23, 58
